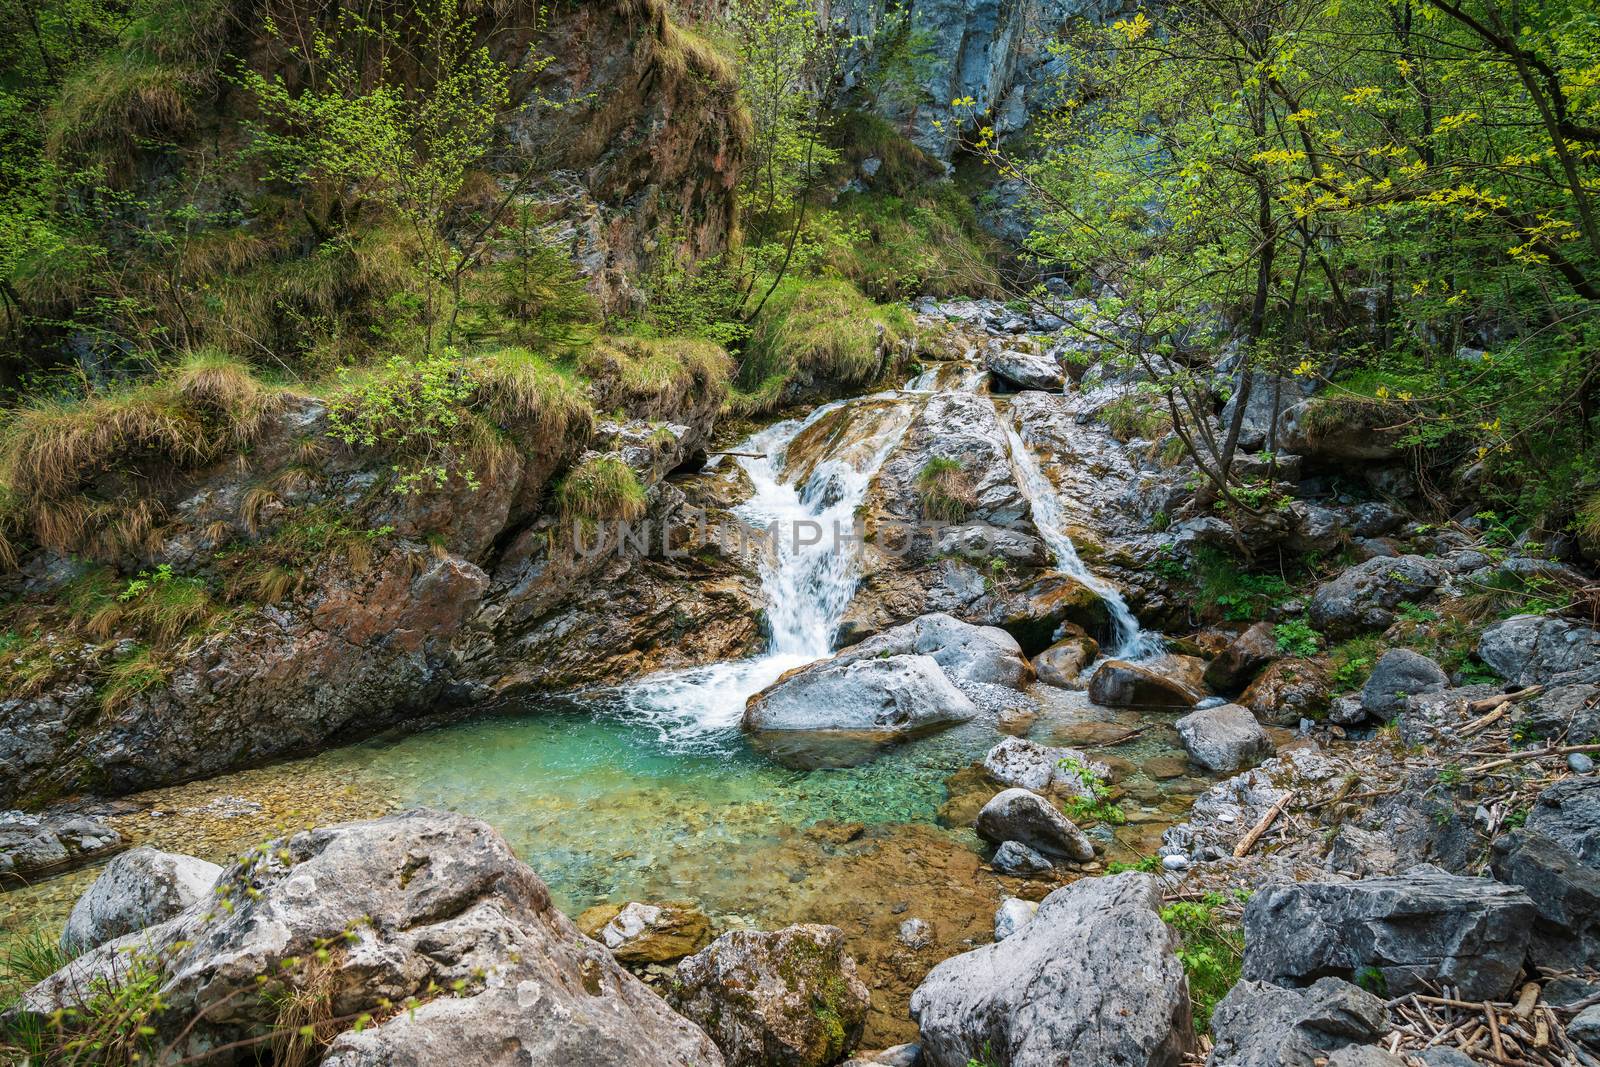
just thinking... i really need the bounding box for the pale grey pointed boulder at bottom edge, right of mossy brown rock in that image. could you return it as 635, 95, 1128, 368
910, 873, 1194, 1067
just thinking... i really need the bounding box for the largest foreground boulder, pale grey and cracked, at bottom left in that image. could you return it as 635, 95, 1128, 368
19, 811, 723, 1067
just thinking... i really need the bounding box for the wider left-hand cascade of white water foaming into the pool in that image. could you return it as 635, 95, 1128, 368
622, 394, 909, 749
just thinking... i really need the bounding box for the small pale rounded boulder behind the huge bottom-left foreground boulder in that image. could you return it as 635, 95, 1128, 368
61, 848, 222, 955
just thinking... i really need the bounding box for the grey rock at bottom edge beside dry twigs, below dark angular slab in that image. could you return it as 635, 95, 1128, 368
1206, 977, 1389, 1067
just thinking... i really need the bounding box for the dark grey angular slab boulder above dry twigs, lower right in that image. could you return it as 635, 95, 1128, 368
1243, 865, 1534, 1000
